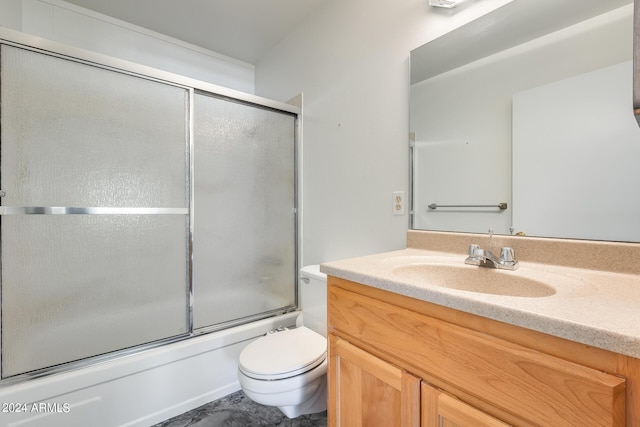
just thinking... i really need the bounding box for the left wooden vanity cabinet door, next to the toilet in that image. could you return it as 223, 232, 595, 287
328, 335, 420, 427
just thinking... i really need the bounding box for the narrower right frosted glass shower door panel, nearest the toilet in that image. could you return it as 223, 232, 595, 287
193, 93, 297, 328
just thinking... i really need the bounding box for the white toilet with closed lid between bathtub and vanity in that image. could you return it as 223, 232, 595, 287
238, 265, 327, 418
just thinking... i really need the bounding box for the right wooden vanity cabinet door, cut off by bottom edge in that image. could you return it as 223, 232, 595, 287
422, 383, 509, 427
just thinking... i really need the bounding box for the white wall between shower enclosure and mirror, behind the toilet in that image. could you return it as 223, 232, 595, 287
256, 0, 509, 265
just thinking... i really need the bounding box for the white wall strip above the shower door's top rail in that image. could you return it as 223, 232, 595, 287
0, 0, 254, 93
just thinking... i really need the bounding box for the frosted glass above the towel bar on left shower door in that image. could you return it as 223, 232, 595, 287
1, 46, 188, 207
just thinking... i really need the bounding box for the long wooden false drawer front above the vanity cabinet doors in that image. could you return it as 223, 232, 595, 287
328, 286, 625, 426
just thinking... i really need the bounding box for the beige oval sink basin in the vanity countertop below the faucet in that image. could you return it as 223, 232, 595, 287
393, 264, 556, 298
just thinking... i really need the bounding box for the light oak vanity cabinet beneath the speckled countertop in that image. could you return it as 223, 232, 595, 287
327, 276, 640, 427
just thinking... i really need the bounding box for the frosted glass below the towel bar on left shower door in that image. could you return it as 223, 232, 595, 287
2, 215, 188, 377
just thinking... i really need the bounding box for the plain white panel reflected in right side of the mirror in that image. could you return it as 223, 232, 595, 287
513, 61, 640, 242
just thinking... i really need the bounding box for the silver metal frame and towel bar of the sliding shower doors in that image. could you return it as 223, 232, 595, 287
0, 28, 302, 387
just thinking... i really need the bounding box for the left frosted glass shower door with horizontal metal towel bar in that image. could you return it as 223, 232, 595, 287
0, 45, 189, 378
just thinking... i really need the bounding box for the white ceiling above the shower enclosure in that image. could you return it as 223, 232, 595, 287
66, 0, 328, 64
